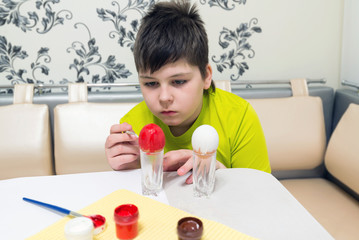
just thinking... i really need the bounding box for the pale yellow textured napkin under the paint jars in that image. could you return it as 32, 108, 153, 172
28, 189, 255, 240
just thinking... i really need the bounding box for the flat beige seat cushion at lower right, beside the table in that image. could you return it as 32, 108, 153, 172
281, 178, 359, 240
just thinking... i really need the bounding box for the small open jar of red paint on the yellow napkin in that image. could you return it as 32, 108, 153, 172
114, 204, 139, 239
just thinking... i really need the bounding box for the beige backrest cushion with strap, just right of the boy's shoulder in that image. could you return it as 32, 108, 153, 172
247, 79, 326, 171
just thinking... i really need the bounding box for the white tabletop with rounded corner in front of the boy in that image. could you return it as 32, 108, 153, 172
0, 169, 333, 240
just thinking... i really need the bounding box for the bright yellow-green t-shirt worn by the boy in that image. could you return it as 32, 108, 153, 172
120, 88, 271, 172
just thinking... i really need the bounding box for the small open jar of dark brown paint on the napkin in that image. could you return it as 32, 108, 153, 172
177, 217, 203, 239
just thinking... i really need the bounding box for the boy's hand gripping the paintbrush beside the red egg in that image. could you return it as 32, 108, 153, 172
105, 123, 140, 170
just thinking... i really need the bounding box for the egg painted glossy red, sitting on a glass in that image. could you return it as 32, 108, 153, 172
138, 123, 165, 152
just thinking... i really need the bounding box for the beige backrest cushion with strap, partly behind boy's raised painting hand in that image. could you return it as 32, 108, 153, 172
54, 84, 137, 174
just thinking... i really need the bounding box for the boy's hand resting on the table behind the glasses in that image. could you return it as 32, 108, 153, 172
163, 149, 226, 184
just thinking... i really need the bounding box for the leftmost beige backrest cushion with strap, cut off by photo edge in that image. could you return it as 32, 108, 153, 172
0, 84, 53, 179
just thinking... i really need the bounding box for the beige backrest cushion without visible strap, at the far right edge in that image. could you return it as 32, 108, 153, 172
325, 103, 359, 194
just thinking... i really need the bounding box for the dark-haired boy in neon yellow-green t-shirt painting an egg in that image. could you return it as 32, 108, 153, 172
105, 1, 271, 183
